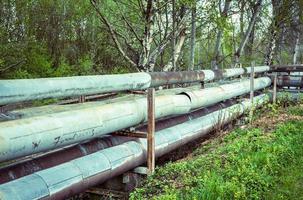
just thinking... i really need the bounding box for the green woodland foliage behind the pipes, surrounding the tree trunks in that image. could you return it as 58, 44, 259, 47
0, 0, 303, 79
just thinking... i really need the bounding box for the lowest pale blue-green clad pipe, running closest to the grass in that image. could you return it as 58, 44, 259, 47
0, 95, 269, 200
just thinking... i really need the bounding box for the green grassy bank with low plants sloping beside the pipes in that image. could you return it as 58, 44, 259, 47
130, 105, 303, 199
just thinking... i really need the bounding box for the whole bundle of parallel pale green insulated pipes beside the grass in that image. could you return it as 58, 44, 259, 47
0, 66, 271, 199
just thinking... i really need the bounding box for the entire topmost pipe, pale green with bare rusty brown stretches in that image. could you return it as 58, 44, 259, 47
0, 67, 266, 105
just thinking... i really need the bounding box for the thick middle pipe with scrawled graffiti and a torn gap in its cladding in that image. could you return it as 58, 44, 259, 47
0, 77, 270, 161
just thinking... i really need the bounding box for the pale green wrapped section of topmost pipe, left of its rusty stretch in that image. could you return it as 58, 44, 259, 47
0, 73, 151, 105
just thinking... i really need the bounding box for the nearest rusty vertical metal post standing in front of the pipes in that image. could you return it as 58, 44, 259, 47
147, 88, 155, 174
